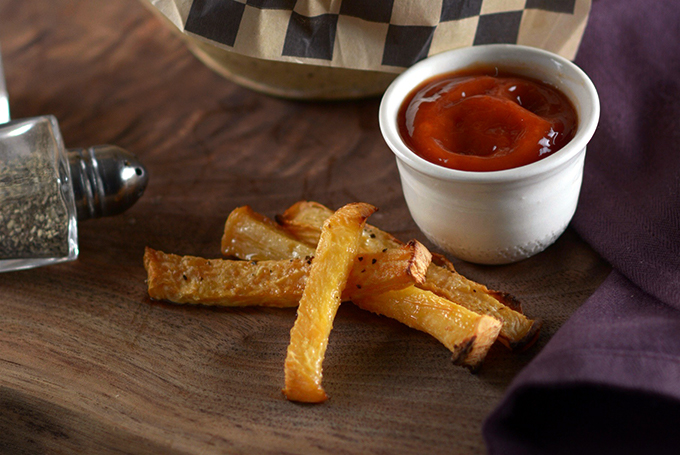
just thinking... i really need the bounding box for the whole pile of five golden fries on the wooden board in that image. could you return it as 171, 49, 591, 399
144, 201, 541, 403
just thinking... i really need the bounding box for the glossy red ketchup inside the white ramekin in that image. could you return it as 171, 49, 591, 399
398, 68, 577, 171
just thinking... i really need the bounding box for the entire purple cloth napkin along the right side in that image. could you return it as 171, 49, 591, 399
484, 0, 680, 455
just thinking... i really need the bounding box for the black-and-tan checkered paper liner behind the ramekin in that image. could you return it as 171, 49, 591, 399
184, 0, 590, 71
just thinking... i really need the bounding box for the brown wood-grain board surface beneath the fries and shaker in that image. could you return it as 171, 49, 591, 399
0, 0, 609, 454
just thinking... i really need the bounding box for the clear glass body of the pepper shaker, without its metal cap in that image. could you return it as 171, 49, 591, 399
0, 116, 78, 270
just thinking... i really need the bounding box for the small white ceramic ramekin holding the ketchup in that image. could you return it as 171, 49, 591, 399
379, 44, 600, 264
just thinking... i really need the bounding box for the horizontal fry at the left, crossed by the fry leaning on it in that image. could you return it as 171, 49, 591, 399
144, 241, 430, 307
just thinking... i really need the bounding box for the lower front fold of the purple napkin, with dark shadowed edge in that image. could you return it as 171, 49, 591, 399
484, 271, 680, 455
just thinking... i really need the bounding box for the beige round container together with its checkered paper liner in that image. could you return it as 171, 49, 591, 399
144, 0, 590, 98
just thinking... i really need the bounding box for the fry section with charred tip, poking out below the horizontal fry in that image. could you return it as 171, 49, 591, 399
353, 286, 502, 370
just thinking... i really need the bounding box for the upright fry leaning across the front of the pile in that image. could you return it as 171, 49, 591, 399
283, 203, 376, 403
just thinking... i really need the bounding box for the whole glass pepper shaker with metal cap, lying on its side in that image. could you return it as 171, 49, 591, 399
0, 116, 148, 272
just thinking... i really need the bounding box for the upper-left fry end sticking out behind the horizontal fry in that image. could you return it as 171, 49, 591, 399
222, 206, 321, 261
